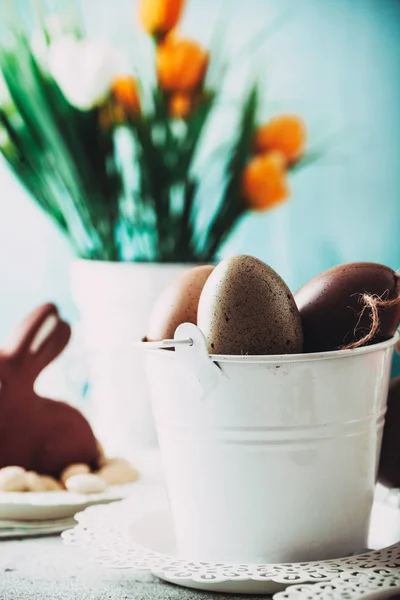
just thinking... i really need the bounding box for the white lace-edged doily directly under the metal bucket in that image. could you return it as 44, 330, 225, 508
63, 486, 400, 600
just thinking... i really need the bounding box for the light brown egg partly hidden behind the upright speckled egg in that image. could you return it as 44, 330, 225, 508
146, 265, 214, 341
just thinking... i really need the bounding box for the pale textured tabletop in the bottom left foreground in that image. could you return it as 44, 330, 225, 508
0, 537, 248, 600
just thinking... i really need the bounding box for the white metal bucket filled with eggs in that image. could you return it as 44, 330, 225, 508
146, 324, 398, 563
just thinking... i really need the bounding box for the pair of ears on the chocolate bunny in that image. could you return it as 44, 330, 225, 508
2, 303, 71, 374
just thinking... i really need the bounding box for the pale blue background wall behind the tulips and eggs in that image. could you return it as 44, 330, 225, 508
0, 0, 400, 339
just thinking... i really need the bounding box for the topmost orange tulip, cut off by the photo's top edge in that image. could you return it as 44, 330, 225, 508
140, 0, 185, 37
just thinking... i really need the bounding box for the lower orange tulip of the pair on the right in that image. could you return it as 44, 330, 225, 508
242, 152, 289, 211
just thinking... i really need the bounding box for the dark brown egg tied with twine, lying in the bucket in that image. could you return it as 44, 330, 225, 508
294, 262, 400, 352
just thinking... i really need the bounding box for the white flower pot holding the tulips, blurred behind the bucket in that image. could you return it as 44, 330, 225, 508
71, 260, 189, 459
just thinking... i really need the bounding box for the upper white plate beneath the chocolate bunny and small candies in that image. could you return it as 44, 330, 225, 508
0, 484, 136, 521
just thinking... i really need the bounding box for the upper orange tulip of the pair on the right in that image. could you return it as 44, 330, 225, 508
255, 115, 307, 162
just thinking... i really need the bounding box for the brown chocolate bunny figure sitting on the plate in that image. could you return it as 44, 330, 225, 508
0, 304, 99, 477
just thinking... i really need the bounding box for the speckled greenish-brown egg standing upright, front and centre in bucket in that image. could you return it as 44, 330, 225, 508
198, 255, 302, 355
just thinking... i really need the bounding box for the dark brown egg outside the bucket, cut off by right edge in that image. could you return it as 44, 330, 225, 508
378, 377, 400, 488
